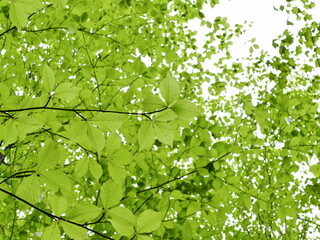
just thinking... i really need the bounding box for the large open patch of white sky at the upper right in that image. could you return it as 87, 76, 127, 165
189, 0, 320, 58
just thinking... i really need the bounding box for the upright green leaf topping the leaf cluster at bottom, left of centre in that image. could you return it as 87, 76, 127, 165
100, 180, 123, 208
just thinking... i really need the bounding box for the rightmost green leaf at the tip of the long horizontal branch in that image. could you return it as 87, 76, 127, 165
171, 99, 198, 120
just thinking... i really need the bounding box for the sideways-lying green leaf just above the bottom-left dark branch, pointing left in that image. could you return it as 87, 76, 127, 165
68, 203, 102, 223
